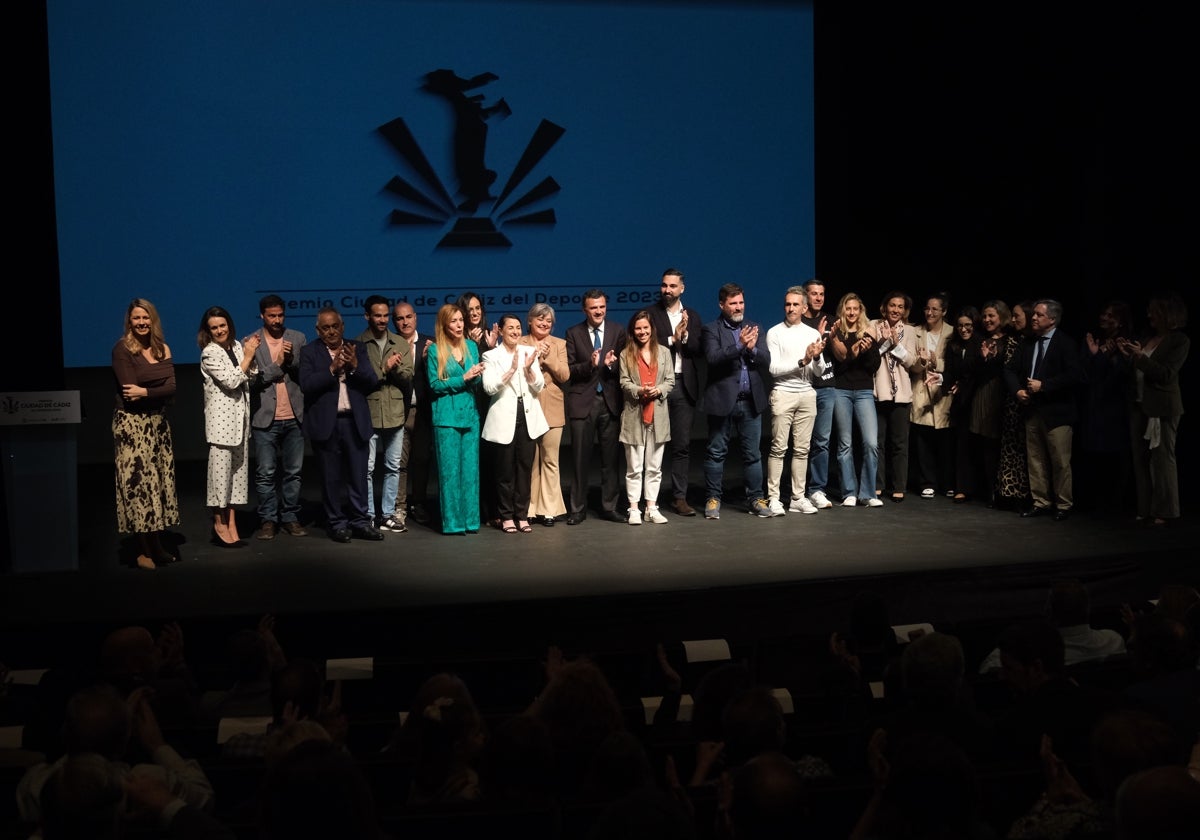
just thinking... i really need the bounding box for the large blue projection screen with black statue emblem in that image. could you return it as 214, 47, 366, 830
48, 0, 815, 367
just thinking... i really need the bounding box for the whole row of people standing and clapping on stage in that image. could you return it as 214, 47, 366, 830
113, 277, 1189, 556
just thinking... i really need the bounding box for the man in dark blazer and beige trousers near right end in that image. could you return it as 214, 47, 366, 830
1004, 299, 1084, 522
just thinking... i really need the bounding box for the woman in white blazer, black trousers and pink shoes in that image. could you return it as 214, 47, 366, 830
484, 314, 550, 534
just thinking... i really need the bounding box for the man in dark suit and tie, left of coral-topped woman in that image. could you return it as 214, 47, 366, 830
566, 289, 625, 524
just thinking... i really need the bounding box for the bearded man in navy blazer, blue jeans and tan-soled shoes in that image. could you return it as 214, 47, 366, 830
701, 283, 770, 520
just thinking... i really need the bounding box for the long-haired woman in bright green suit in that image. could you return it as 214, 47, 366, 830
425, 304, 484, 534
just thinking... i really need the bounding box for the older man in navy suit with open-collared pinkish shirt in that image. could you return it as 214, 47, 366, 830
300, 307, 383, 542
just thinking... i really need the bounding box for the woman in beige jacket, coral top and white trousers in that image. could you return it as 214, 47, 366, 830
620, 310, 674, 524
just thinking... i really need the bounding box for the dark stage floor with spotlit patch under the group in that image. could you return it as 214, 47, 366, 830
0, 461, 1200, 638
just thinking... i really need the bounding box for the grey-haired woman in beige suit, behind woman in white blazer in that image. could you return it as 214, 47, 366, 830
521, 304, 571, 528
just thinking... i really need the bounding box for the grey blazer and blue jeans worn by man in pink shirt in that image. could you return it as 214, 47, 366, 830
250, 329, 306, 522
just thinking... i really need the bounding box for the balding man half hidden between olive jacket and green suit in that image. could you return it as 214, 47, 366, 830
391, 301, 433, 524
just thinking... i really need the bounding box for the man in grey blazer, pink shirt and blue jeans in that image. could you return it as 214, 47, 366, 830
250, 294, 307, 540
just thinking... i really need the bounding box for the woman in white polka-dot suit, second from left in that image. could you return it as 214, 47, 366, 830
197, 306, 259, 548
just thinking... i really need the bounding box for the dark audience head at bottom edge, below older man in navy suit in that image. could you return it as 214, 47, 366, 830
259, 740, 379, 840
